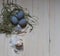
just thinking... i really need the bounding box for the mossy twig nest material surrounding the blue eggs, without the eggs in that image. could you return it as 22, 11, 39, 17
0, 3, 35, 34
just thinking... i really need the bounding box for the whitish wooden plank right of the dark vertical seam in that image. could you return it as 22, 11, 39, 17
50, 0, 60, 56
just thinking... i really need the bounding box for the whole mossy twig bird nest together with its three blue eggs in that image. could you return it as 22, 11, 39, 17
0, 3, 36, 34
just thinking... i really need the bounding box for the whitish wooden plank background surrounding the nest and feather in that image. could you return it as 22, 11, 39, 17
0, 0, 60, 56
